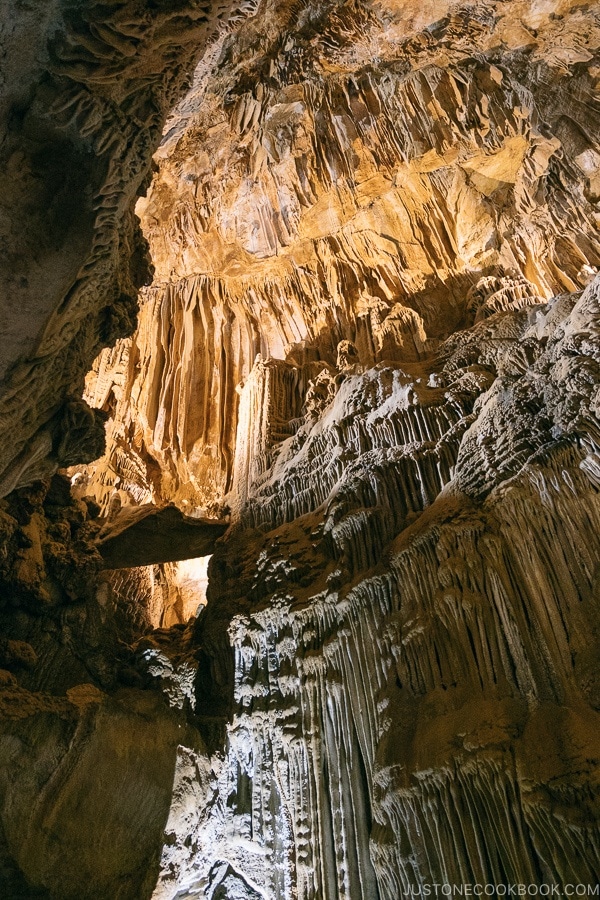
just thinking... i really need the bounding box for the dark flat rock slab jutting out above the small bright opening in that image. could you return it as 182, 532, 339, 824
97, 503, 229, 569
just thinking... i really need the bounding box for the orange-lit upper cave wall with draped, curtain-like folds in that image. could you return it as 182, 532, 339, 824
81, 3, 600, 509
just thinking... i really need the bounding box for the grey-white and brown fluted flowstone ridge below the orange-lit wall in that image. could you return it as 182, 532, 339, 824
158, 280, 600, 900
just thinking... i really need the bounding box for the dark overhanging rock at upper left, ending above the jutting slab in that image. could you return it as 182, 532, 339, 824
0, 0, 237, 496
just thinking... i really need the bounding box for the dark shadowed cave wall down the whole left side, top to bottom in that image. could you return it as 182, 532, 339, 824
0, 0, 237, 900
